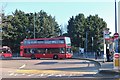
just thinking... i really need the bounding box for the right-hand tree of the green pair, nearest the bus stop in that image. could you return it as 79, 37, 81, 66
86, 15, 107, 51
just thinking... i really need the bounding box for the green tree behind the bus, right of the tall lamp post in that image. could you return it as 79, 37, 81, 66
32, 10, 60, 38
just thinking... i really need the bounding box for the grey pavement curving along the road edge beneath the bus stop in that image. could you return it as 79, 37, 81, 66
73, 54, 120, 78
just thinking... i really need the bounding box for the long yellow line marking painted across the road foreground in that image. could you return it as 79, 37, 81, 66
16, 70, 97, 74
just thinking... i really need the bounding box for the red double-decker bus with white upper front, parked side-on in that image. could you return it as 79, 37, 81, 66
20, 37, 73, 59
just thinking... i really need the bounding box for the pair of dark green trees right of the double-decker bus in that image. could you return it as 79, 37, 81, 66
67, 14, 107, 51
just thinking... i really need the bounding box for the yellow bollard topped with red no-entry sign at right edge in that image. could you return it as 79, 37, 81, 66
114, 53, 120, 72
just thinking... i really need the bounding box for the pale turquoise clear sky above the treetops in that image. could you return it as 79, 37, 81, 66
0, 0, 119, 35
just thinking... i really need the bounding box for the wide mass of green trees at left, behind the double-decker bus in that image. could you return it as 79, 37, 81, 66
2, 10, 60, 52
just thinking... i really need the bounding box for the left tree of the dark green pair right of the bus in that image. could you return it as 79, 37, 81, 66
67, 14, 85, 47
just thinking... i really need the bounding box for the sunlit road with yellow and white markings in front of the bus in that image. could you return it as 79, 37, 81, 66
0, 59, 98, 78
